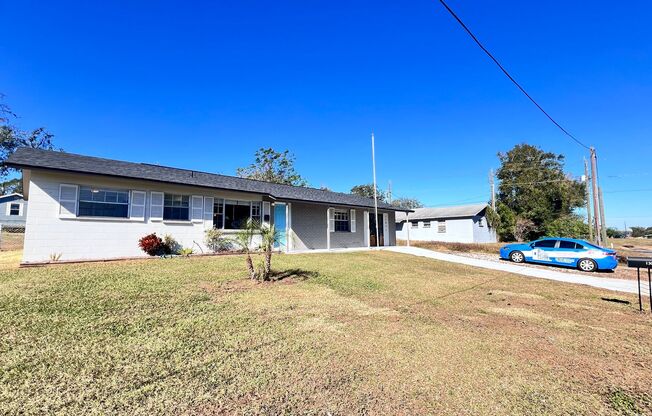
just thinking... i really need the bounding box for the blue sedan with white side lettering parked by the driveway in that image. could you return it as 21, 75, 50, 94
500, 238, 618, 272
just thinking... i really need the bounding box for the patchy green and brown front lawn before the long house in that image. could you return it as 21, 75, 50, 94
0, 252, 652, 415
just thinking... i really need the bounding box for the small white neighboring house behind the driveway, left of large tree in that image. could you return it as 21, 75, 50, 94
396, 204, 497, 243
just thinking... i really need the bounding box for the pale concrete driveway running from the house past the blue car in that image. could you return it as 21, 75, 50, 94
383, 246, 648, 294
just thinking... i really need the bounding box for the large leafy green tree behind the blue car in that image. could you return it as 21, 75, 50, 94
496, 144, 586, 241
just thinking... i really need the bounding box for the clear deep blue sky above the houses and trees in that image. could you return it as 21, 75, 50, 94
0, 0, 652, 228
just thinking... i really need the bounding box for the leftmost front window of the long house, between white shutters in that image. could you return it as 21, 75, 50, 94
78, 186, 129, 218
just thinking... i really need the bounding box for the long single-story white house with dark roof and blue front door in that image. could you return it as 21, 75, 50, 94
7, 148, 408, 263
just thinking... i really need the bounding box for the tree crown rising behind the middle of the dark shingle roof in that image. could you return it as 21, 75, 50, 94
236, 147, 308, 186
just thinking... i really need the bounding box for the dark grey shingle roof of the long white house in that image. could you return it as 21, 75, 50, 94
7, 147, 408, 211
